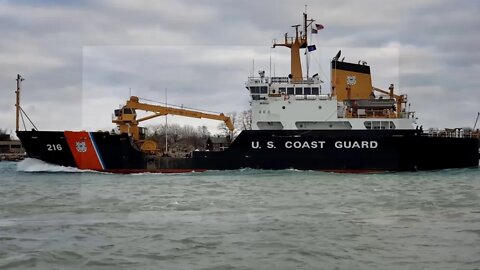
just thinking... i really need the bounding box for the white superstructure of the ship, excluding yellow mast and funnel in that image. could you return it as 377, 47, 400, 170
246, 72, 414, 130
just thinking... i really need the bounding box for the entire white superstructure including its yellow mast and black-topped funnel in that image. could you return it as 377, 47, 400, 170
246, 13, 415, 130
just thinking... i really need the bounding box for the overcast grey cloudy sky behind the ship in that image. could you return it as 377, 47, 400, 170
0, 0, 480, 135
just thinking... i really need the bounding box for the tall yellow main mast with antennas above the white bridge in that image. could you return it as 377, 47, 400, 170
273, 13, 313, 81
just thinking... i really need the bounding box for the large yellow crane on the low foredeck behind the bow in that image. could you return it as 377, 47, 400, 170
112, 96, 234, 153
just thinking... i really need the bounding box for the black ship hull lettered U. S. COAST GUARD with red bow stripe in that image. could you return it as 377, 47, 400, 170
17, 130, 479, 173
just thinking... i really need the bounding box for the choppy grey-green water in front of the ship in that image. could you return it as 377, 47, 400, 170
0, 160, 480, 269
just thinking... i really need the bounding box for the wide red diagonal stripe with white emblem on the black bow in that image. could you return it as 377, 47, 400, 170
64, 131, 105, 171
